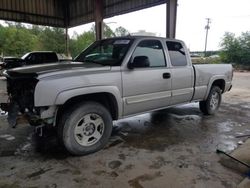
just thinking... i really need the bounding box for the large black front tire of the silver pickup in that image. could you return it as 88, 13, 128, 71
58, 102, 113, 155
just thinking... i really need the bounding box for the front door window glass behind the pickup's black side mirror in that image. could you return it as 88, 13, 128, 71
132, 40, 166, 67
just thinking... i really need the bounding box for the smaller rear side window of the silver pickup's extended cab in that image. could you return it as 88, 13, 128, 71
167, 41, 187, 66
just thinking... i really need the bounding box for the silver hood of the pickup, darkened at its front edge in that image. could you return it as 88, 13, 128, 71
5, 62, 110, 77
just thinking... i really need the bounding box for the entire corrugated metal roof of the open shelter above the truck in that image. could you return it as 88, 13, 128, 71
0, 0, 166, 28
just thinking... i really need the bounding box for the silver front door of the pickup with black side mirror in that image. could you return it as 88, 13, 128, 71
122, 39, 171, 116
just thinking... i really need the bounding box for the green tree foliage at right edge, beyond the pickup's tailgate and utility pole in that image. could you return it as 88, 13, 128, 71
221, 31, 250, 66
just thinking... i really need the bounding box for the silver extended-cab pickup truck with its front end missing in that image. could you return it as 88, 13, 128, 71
1, 36, 233, 155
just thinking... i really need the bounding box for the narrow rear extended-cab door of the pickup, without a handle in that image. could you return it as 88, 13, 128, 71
166, 41, 194, 105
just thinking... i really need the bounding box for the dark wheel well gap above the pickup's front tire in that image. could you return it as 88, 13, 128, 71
56, 93, 118, 122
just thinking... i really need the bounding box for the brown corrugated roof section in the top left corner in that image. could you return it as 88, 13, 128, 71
0, 0, 64, 27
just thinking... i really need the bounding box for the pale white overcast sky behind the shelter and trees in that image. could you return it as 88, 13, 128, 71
69, 0, 250, 51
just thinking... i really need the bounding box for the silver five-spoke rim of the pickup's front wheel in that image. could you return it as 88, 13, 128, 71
74, 113, 104, 146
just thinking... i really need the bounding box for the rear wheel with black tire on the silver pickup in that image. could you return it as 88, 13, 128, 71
200, 86, 221, 115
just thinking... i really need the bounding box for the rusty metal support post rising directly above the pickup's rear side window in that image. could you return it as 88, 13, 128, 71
166, 0, 177, 38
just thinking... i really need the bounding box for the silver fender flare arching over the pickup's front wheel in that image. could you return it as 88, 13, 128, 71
55, 86, 123, 117
